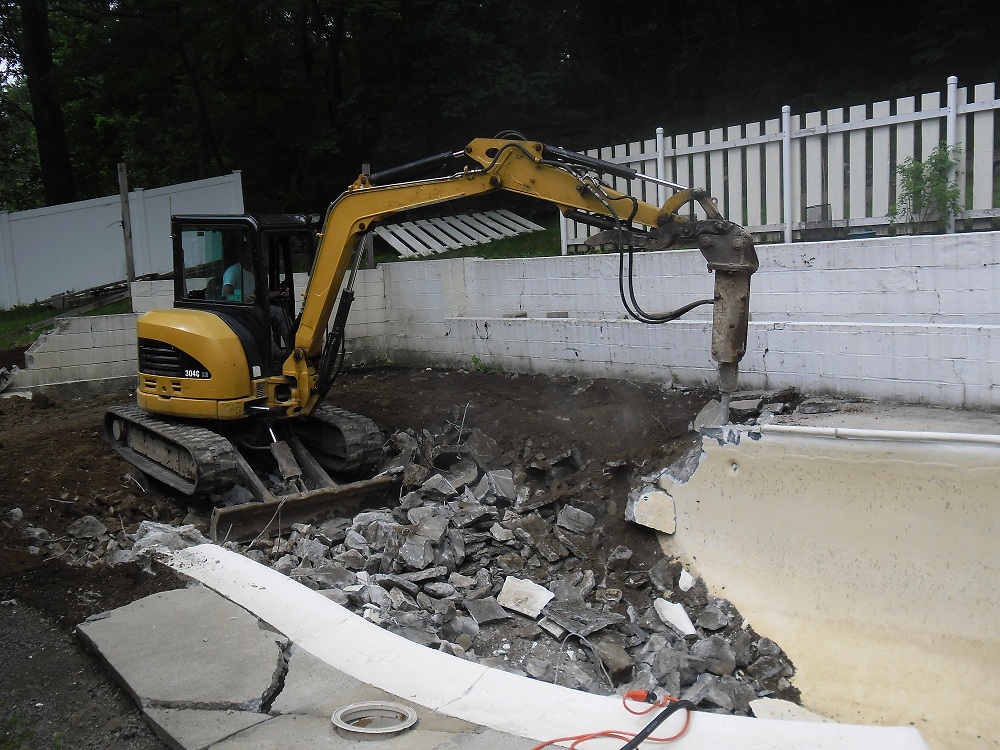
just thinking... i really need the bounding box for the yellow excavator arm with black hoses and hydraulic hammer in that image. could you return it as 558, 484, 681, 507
282, 138, 757, 416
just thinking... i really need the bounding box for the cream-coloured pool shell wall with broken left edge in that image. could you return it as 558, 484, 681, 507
640, 424, 1000, 748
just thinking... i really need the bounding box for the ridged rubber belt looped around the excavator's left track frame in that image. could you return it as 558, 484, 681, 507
104, 405, 236, 495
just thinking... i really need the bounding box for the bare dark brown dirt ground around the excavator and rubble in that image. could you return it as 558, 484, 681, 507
0, 369, 712, 750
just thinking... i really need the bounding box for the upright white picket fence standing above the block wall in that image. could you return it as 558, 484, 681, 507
562, 76, 1000, 254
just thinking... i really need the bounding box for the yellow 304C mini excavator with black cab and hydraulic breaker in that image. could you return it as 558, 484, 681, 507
104, 138, 757, 530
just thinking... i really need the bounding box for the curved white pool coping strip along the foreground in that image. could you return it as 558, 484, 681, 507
166, 544, 927, 750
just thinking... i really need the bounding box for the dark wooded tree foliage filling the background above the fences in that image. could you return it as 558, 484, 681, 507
0, 0, 1000, 213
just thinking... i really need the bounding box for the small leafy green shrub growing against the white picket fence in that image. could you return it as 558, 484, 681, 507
889, 143, 962, 233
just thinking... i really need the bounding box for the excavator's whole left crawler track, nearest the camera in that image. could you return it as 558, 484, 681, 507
104, 405, 237, 495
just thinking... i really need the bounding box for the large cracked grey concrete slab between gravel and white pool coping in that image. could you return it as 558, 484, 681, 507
77, 586, 287, 711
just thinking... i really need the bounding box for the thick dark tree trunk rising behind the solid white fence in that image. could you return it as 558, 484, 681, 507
18, 0, 76, 206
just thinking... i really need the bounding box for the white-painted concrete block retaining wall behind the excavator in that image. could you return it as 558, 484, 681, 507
17, 232, 1000, 408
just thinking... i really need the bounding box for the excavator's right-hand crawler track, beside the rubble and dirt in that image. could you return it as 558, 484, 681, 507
293, 406, 382, 474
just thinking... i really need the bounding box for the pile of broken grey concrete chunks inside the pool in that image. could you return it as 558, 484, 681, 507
4, 418, 797, 715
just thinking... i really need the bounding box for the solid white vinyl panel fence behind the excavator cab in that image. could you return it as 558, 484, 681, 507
0, 172, 243, 310
